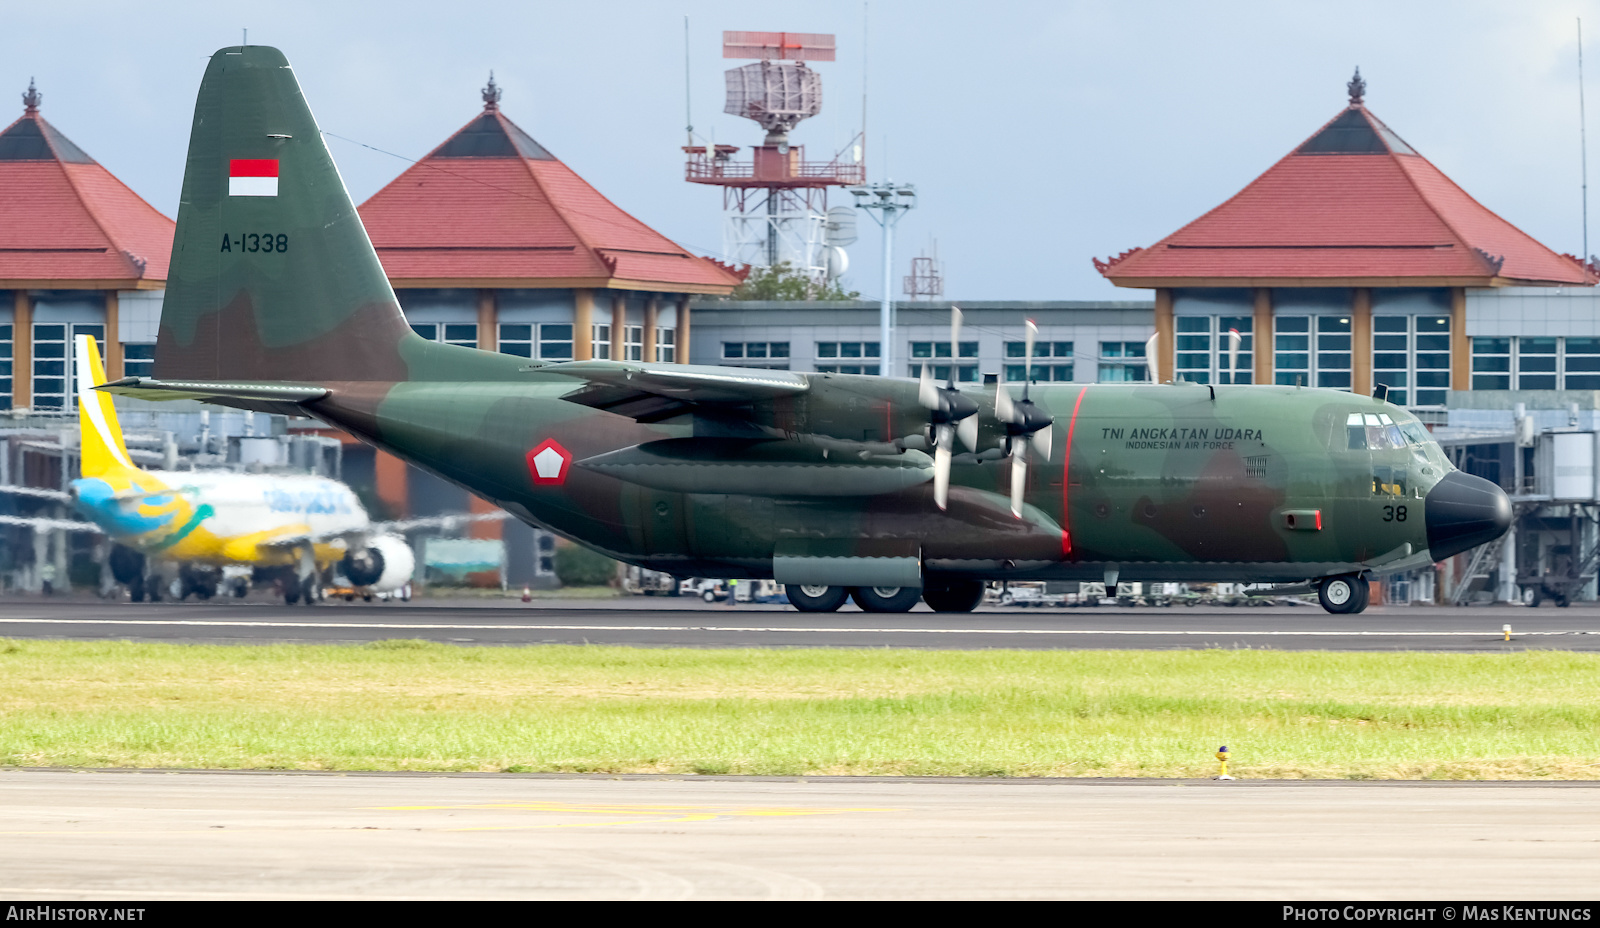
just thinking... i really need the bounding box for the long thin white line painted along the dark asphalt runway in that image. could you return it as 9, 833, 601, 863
0, 619, 1600, 640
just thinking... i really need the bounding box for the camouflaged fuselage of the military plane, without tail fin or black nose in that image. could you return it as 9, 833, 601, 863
307, 352, 1448, 581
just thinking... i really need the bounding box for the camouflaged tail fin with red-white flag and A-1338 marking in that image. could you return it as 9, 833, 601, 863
154, 46, 421, 382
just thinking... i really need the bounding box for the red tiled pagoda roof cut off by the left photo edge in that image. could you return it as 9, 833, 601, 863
0, 99, 174, 290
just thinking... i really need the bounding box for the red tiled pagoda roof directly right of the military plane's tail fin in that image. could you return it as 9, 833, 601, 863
360, 104, 739, 294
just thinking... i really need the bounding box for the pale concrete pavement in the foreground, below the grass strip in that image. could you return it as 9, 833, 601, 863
0, 770, 1600, 902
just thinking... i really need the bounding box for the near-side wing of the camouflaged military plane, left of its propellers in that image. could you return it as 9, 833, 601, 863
534, 362, 811, 422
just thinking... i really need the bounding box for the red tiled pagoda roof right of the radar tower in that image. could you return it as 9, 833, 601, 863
1094, 101, 1600, 286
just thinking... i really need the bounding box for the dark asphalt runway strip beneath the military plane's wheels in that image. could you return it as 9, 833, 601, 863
0, 597, 1600, 653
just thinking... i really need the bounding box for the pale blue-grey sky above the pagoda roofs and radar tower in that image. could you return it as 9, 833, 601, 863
9, 0, 1600, 299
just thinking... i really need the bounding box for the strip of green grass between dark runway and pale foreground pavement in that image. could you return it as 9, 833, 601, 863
0, 640, 1600, 779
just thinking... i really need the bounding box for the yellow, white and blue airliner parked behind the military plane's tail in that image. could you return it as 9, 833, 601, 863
70, 336, 416, 605
